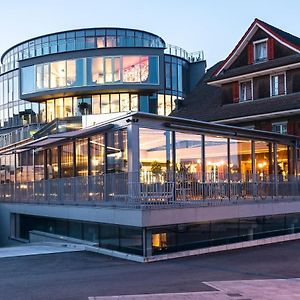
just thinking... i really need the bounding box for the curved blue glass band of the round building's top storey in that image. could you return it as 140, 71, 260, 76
1, 28, 166, 72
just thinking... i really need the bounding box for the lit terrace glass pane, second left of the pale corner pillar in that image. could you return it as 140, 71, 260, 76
90, 134, 105, 176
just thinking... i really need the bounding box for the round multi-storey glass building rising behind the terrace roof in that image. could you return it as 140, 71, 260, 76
0, 28, 205, 128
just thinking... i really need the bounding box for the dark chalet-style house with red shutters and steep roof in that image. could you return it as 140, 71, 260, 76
174, 19, 300, 135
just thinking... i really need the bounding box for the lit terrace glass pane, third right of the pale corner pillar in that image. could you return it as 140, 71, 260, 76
205, 135, 228, 182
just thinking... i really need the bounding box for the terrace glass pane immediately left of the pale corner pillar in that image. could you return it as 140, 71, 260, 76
106, 129, 127, 173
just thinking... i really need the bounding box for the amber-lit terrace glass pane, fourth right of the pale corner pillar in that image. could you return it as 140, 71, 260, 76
229, 139, 252, 181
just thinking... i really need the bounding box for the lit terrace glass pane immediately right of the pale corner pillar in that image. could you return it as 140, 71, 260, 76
139, 128, 172, 182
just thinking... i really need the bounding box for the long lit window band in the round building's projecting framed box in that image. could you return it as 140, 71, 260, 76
21, 55, 159, 95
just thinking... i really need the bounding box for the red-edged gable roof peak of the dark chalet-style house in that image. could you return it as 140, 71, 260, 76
213, 19, 300, 76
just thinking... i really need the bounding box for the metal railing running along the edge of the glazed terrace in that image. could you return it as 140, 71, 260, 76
0, 173, 300, 208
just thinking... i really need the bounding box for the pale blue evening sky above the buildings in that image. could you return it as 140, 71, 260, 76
0, 0, 300, 66
